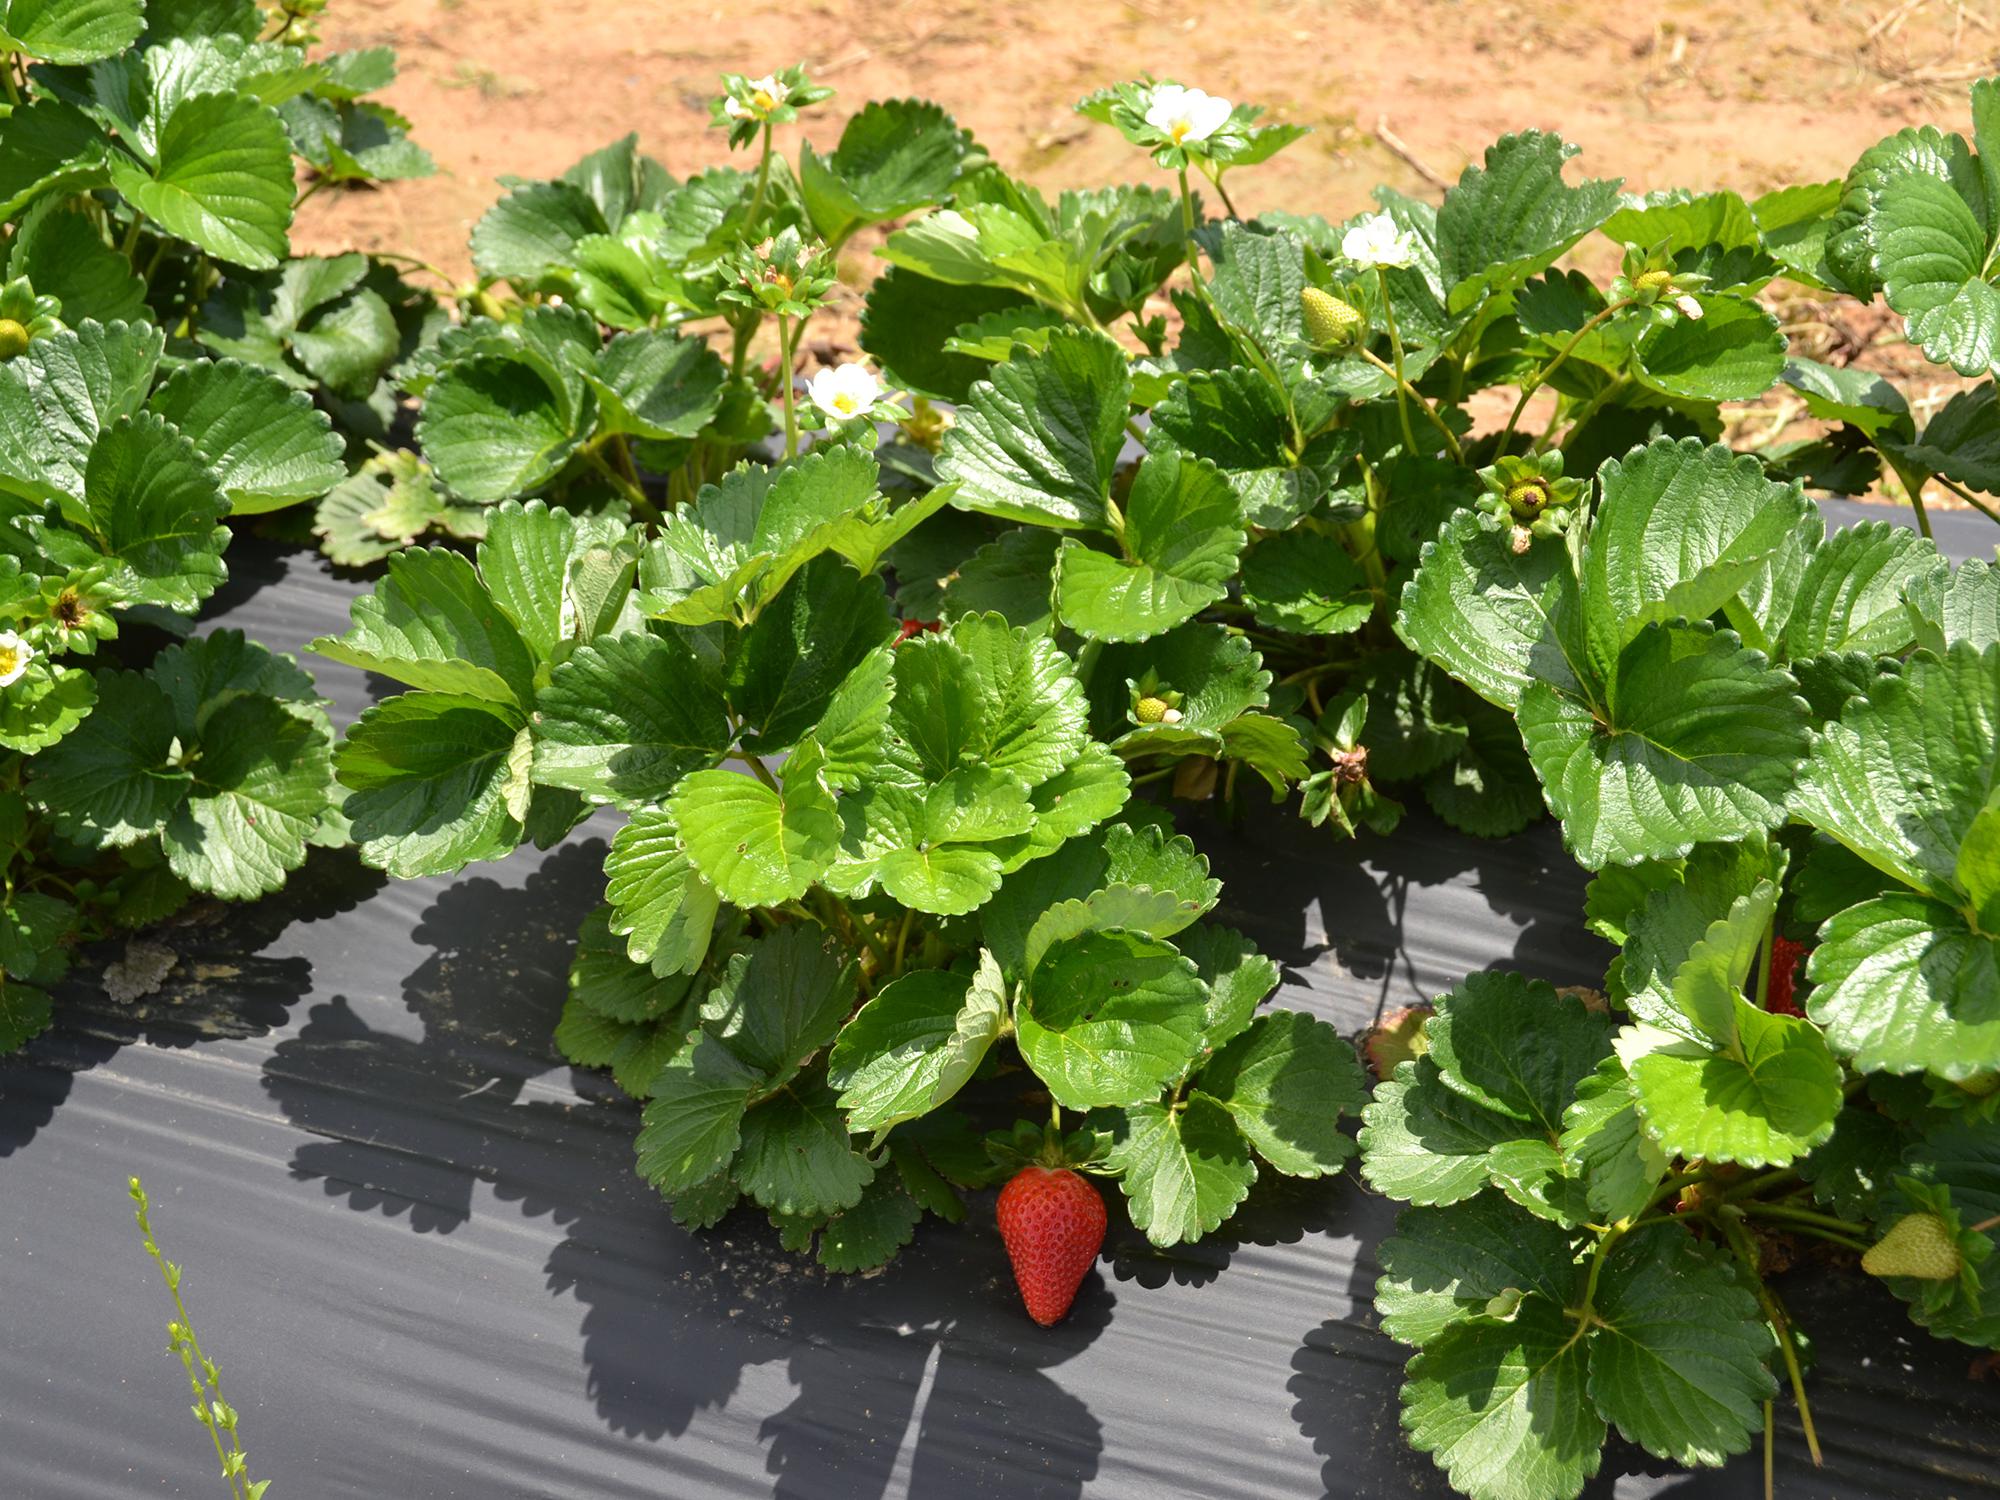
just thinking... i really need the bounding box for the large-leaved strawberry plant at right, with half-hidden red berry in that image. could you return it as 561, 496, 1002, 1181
1362, 368, 2000, 1500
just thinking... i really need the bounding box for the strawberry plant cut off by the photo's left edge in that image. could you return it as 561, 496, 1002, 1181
0, 0, 422, 1050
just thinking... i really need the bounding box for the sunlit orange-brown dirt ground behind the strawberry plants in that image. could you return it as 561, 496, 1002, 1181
294, 0, 2000, 506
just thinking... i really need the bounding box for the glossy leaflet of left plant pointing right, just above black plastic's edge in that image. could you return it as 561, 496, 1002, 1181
148, 360, 346, 516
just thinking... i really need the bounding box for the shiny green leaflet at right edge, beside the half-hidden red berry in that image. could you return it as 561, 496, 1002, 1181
1806, 892, 2000, 1078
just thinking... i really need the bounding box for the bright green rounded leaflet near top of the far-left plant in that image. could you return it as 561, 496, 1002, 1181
110, 94, 294, 270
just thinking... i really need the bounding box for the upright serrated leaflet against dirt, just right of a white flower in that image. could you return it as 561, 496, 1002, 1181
1438, 130, 1618, 312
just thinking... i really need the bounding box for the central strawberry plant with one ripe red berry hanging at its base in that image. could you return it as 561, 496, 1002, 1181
314, 472, 1362, 1280
